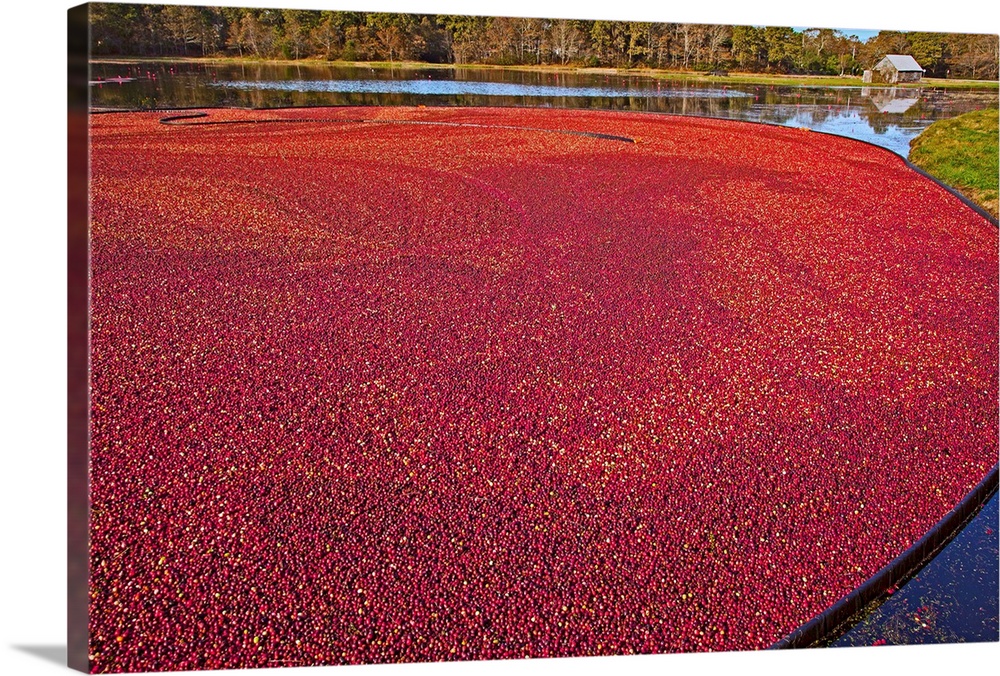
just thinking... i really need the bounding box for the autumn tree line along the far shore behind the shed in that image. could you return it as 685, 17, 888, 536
90, 3, 1000, 79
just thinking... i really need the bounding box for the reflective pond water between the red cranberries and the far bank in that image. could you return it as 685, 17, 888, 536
91, 62, 997, 157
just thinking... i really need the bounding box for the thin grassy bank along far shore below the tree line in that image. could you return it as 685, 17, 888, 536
92, 57, 998, 89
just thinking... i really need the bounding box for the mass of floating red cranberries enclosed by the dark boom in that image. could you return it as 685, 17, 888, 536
90, 108, 998, 672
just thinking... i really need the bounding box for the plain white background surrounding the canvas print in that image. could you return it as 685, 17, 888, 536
0, 0, 1000, 676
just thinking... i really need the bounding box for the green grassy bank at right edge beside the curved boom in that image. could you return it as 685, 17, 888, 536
910, 108, 1000, 218
